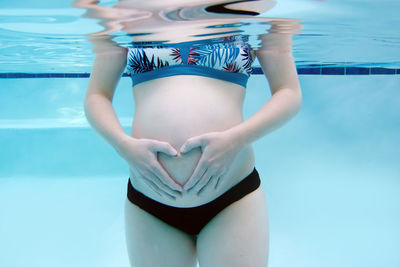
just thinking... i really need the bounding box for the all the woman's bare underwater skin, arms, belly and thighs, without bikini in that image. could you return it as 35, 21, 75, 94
84, 27, 302, 267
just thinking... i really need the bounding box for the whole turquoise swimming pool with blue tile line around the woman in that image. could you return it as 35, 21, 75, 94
0, 0, 400, 267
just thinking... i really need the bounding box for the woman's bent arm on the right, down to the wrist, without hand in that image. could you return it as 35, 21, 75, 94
229, 33, 302, 148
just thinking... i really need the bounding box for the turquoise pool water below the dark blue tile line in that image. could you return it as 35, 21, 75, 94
0, 75, 400, 267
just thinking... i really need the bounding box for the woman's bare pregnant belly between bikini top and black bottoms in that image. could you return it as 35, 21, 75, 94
130, 75, 254, 207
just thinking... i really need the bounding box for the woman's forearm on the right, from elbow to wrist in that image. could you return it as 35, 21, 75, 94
229, 88, 302, 145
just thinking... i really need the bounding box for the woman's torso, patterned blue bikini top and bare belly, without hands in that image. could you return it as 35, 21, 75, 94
128, 36, 255, 207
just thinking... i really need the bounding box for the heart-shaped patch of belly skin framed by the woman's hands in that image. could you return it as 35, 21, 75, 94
158, 147, 202, 187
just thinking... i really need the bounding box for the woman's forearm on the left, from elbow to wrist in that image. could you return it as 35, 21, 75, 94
84, 94, 128, 151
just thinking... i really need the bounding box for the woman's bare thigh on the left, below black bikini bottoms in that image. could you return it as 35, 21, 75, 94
125, 199, 197, 267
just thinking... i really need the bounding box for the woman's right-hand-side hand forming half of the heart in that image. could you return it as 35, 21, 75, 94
180, 130, 243, 195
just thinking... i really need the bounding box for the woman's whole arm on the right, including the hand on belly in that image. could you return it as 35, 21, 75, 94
180, 30, 302, 194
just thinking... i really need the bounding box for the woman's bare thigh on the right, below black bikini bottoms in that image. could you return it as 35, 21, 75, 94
197, 186, 269, 267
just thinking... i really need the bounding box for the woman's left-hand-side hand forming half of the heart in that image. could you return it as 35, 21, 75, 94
116, 135, 183, 199
